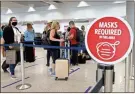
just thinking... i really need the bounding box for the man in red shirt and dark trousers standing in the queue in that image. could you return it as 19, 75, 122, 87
68, 21, 78, 66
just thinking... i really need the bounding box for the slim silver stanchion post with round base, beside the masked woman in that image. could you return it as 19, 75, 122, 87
16, 43, 31, 90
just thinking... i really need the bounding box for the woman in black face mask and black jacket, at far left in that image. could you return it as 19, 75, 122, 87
2, 17, 21, 78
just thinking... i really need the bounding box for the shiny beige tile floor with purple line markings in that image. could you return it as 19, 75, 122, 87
1, 48, 134, 92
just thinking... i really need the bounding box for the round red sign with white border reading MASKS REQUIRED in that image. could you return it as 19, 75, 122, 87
85, 16, 133, 64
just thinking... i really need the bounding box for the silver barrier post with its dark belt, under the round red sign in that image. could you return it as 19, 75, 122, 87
87, 64, 115, 93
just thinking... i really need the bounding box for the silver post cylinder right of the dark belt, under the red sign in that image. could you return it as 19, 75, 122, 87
104, 65, 114, 93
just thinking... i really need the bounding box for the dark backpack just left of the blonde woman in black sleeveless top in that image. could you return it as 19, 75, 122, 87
42, 30, 51, 45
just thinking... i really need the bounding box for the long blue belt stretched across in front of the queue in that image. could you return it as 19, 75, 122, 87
0, 44, 86, 50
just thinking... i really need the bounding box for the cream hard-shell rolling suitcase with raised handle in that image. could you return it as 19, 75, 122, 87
55, 40, 69, 80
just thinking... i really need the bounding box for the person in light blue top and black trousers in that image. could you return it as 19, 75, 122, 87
24, 23, 35, 63
